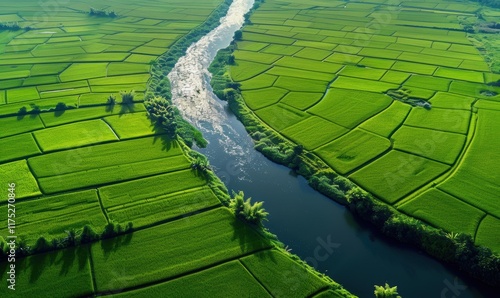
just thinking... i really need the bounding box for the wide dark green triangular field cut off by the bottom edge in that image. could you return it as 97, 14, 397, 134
113, 261, 272, 298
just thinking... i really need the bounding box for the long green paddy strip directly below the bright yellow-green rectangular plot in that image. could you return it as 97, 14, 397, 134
28, 137, 182, 177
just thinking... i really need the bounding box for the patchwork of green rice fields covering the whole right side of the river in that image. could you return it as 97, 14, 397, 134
230, 0, 500, 252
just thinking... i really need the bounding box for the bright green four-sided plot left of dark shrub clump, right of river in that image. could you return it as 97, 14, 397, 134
308, 89, 392, 128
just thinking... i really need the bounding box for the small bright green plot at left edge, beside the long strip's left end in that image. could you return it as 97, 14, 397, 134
0, 160, 41, 199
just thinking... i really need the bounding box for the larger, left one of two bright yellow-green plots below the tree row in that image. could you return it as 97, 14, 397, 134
33, 120, 118, 152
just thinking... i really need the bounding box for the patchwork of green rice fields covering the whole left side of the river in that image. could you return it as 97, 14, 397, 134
0, 0, 356, 297
